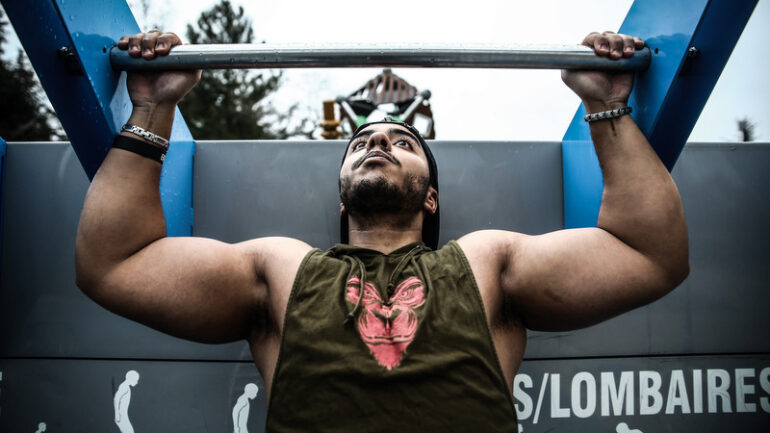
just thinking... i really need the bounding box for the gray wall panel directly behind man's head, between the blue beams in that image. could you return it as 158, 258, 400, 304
194, 141, 563, 245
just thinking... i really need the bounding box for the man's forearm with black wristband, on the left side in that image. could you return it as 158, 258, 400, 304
76, 107, 174, 289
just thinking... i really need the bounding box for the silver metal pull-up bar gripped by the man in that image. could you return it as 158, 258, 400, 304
110, 44, 651, 71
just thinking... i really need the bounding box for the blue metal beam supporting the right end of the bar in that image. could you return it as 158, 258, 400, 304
562, 0, 758, 228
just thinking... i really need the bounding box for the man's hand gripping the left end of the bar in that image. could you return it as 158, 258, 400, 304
118, 30, 201, 109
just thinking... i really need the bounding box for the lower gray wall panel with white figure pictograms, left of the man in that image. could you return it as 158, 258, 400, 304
0, 360, 267, 433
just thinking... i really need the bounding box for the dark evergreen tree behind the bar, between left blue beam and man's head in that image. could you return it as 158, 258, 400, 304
180, 0, 309, 140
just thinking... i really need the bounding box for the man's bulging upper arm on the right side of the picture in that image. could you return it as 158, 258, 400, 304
502, 228, 669, 331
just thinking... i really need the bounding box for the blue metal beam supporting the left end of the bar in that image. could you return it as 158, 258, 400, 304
0, 0, 195, 236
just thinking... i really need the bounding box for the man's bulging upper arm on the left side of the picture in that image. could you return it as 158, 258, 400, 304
89, 237, 266, 343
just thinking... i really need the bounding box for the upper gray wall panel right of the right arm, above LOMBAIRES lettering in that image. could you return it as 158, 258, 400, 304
654, 144, 770, 352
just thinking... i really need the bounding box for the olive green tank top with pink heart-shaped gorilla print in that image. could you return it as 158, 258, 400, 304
266, 242, 517, 433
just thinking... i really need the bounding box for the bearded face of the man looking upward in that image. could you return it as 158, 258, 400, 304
340, 123, 432, 221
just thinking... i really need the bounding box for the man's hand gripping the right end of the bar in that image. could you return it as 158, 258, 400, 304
561, 32, 644, 113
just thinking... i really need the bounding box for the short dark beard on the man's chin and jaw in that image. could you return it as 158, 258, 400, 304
340, 173, 430, 226
